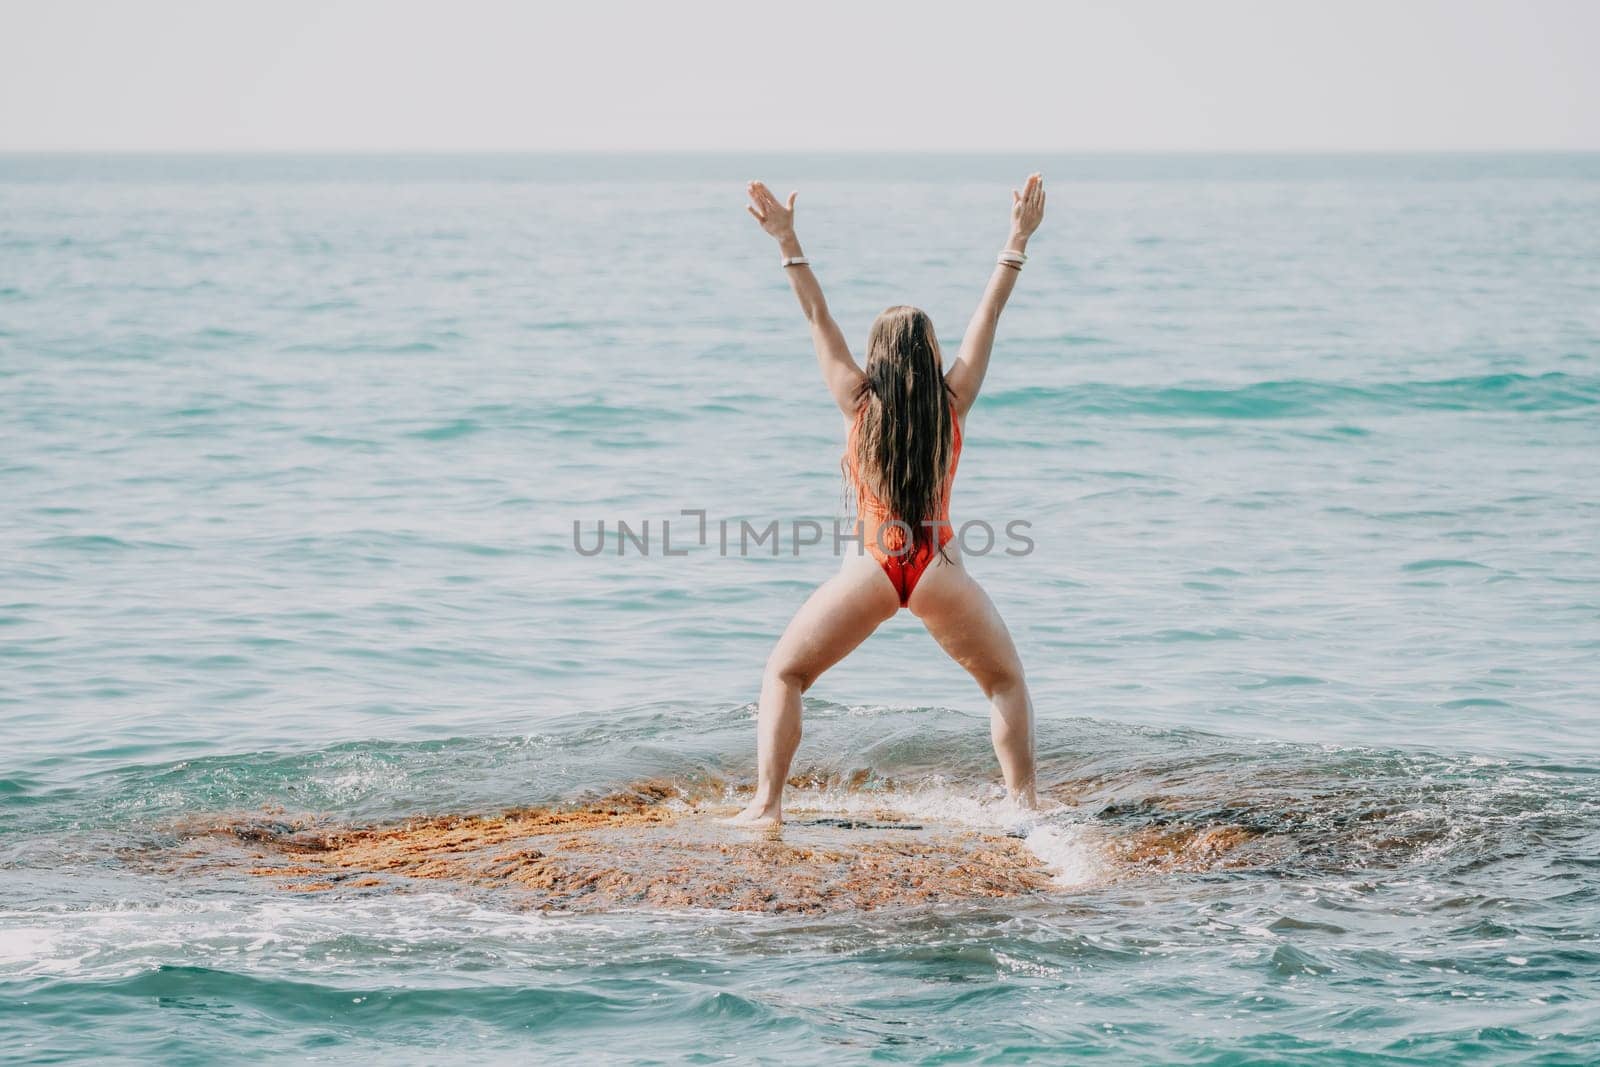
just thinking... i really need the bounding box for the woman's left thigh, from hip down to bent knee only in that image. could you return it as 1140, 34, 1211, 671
766, 557, 899, 688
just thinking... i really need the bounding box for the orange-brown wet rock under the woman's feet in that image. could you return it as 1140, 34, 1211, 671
189, 790, 1053, 913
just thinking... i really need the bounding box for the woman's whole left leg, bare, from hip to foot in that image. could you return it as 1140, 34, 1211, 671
733, 555, 899, 825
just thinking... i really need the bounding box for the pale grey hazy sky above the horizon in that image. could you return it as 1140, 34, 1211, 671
0, 0, 1600, 152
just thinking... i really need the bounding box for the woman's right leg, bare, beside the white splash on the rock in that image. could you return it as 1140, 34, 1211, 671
910, 556, 1038, 808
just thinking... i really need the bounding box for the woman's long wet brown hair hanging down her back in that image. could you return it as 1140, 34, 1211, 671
845, 304, 955, 555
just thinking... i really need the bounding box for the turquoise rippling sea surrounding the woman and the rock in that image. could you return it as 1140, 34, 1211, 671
0, 155, 1600, 1064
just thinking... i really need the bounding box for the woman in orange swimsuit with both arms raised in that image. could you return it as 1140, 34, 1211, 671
733, 173, 1045, 825
